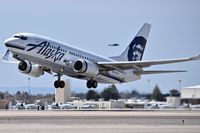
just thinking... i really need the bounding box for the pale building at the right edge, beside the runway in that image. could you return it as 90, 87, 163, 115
181, 85, 200, 105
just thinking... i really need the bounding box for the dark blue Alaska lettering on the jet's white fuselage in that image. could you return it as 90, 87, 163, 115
26, 41, 65, 62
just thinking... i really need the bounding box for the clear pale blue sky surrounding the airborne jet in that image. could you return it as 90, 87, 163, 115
0, 0, 200, 92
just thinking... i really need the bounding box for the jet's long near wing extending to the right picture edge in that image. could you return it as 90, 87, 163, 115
97, 55, 200, 70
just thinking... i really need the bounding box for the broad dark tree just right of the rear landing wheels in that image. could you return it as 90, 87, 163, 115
101, 84, 119, 101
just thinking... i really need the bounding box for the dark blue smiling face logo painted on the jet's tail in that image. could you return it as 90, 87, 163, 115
128, 36, 147, 61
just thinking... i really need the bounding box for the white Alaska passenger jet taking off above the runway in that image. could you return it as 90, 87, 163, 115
3, 23, 200, 88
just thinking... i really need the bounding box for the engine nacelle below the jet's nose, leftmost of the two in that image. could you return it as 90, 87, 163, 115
18, 61, 44, 77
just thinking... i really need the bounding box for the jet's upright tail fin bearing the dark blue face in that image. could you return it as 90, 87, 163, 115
111, 23, 151, 61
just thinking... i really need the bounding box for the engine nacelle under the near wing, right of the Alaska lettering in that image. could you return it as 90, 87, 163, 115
73, 59, 99, 77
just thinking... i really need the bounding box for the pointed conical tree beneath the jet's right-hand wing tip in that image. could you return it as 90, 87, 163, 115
152, 84, 164, 101
